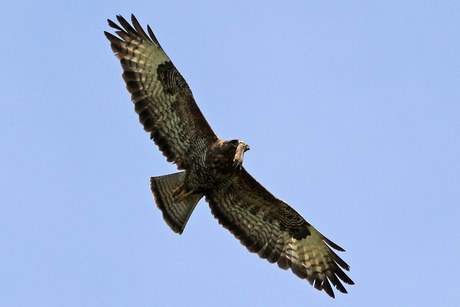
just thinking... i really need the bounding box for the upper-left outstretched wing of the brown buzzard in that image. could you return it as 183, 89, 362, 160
104, 15, 218, 169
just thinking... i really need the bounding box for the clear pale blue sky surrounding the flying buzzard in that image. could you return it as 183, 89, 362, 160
0, 0, 460, 306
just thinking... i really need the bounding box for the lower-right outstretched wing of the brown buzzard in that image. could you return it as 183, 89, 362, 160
206, 169, 354, 297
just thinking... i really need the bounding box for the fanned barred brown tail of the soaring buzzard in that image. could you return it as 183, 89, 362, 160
150, 172, 203, 234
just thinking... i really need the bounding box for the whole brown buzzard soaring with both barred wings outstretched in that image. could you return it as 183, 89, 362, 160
104, 15, 354, 297
